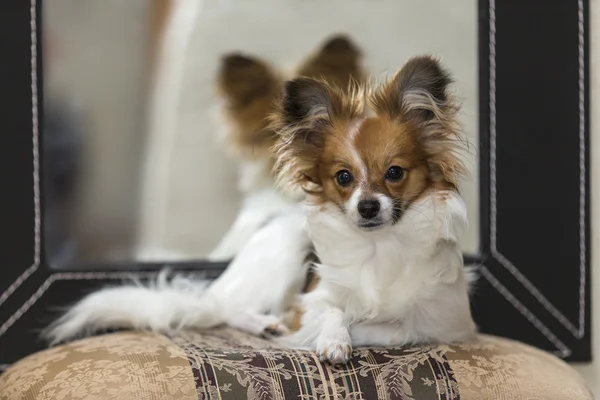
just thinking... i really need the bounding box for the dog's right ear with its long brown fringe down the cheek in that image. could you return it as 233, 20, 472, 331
370, 56, 465, 186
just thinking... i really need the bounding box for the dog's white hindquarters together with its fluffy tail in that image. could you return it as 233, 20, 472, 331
44, 205, 311, 343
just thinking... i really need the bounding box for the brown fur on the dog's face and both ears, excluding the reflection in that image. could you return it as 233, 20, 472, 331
271, 56, 464, 208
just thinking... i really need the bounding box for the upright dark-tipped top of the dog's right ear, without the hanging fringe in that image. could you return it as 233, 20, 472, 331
373, 56, 453, 125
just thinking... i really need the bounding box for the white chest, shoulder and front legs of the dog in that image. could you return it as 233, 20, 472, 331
281, 191, 475, 363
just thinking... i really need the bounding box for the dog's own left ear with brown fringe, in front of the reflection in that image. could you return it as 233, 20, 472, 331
270, 78, 340, 190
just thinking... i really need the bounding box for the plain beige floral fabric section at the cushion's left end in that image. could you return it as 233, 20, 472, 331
0, 332, 198, 400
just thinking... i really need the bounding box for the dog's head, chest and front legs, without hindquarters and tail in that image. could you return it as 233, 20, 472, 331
270, 56, 476, 364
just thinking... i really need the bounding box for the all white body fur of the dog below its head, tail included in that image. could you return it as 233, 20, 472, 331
46, 191, 475, 364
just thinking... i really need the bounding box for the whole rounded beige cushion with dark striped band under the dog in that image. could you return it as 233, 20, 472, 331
0, 329, 592, 400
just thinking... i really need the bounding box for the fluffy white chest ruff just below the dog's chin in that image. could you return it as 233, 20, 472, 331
308, 206, 435, 321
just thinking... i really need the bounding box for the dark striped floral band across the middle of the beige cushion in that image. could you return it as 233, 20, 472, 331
173, 329, 460, 400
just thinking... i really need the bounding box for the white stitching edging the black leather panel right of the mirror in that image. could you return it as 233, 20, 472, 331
489, 0, 586, 339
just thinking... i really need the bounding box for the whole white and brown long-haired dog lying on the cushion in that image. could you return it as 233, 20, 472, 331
47, 48, 475, 364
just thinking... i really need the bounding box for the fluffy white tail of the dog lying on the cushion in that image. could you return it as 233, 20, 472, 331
42, 270, 223, 344
